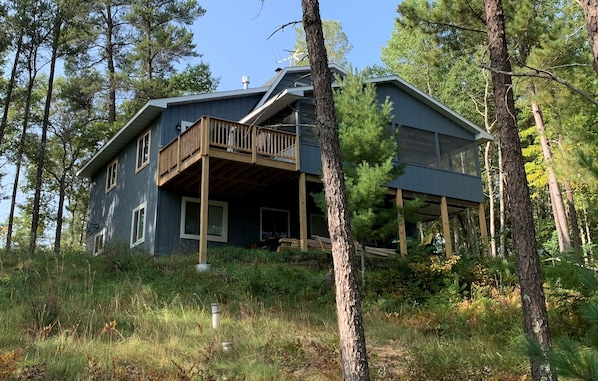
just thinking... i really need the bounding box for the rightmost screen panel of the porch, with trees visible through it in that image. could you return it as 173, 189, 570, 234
438, 134, 478, 176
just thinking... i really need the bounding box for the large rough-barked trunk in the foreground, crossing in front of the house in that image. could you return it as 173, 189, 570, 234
301, 0, 370, 381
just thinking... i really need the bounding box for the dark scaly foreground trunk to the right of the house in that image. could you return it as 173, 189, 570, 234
484, 0, 557, 381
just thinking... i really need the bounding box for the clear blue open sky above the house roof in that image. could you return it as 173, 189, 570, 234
193, 0, 400, 91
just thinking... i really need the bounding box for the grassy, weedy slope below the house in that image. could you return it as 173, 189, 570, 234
0, 246, 528, 381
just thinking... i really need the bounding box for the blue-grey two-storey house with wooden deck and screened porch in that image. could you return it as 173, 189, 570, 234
79, 65, 492, 263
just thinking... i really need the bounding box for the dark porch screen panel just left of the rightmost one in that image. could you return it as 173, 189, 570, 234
397, 126, 438, 168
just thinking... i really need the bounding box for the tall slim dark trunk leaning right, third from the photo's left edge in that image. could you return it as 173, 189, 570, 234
29, 10, 62, 255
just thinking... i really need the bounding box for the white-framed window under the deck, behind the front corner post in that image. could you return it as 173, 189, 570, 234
181, 197, 228, 242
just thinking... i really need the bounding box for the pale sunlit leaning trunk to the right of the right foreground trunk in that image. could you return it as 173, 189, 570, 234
531, 93, 571, 253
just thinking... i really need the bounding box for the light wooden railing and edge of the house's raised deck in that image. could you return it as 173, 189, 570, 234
157, 116, 299, 186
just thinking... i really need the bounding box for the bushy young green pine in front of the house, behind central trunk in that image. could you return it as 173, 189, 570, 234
312, 72, 400, 246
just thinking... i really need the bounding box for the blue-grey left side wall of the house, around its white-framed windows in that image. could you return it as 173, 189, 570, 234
87, 119, 159, 253
